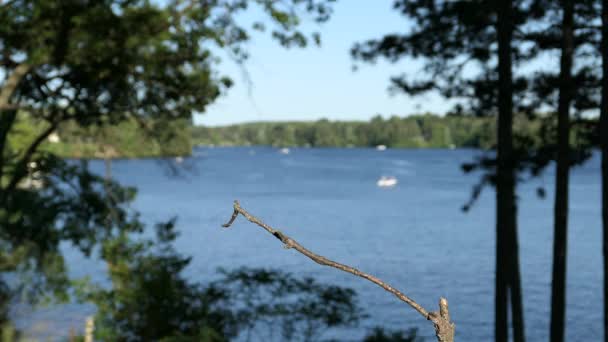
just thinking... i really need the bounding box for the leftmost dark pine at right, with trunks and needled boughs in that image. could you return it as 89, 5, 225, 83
352, 1, 544, 341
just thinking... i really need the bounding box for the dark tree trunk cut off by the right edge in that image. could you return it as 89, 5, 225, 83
600, 0, 608, 342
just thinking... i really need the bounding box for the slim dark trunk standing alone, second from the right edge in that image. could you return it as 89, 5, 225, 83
551, 0, 574, 342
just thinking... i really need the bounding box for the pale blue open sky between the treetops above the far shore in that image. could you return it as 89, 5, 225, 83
195, 0, 449, 126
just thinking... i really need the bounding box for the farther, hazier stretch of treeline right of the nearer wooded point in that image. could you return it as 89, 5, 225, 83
192, 114, 539, 148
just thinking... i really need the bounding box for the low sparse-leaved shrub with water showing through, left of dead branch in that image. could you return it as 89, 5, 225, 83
211, 268, 364, 341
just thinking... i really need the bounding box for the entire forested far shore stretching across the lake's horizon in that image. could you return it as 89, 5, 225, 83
20, 114, 597, 159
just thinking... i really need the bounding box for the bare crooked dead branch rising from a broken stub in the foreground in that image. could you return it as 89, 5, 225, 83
222, 201, 455, 342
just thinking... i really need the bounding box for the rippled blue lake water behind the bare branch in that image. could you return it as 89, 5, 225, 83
21, 147, 603, 341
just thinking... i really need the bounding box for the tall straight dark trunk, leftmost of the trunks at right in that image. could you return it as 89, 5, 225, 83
494, 0, 513, 342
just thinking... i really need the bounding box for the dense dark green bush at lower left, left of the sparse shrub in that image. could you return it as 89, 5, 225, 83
79, 222, 237, 341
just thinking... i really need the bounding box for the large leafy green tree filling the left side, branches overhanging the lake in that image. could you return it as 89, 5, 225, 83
0, 0, 332, 324
